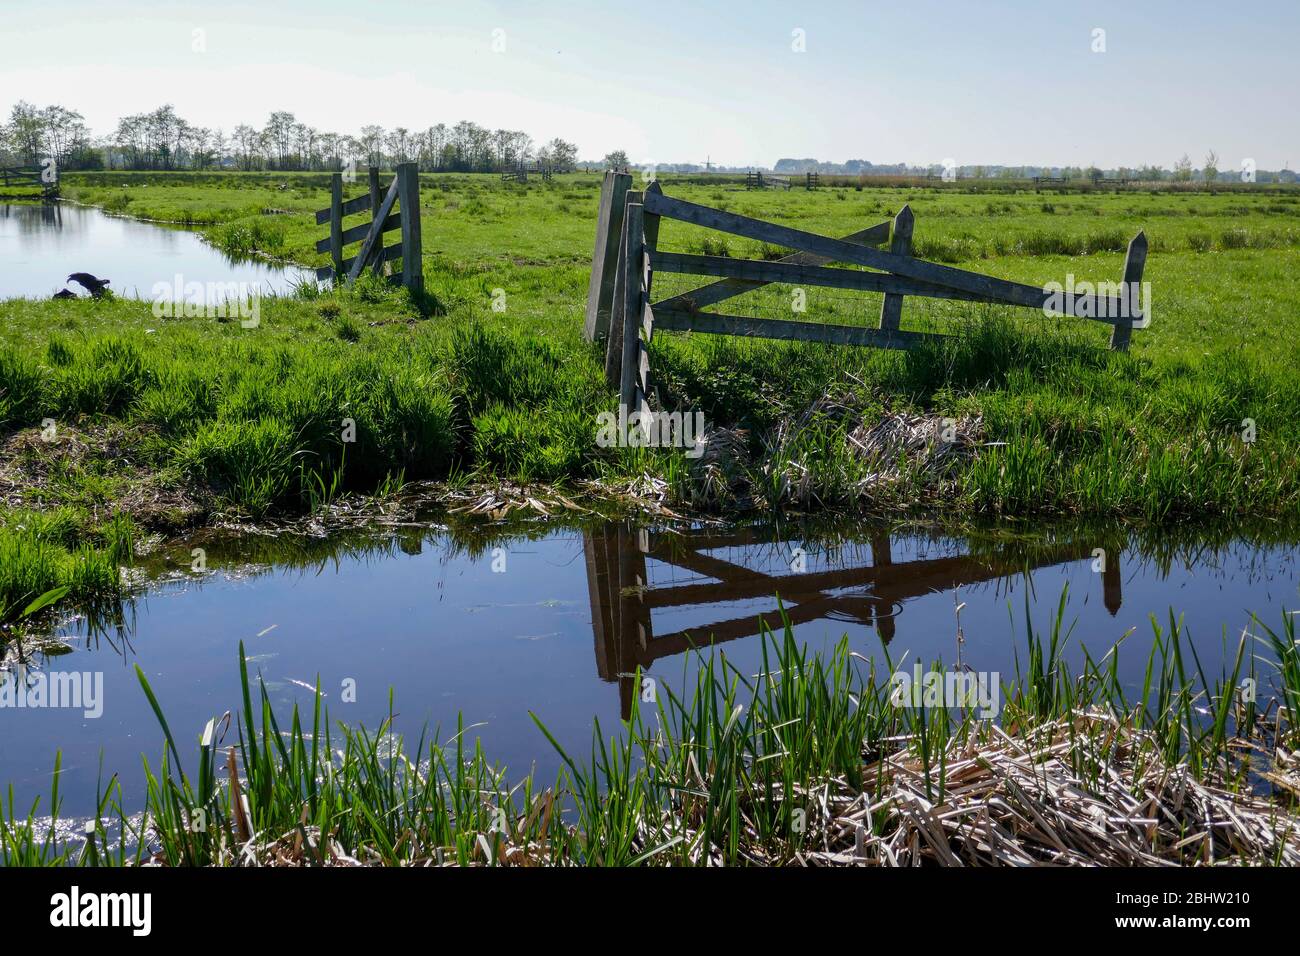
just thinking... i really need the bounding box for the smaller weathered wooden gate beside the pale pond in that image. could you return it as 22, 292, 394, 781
316, 163, 424, 293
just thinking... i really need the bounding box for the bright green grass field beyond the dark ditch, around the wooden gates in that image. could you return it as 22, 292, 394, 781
0, 173, 1300, 611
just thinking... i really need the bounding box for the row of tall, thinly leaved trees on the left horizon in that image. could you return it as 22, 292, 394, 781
0, 100, 577, 173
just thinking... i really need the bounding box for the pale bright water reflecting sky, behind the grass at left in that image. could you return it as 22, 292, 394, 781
0, 203, 309, 300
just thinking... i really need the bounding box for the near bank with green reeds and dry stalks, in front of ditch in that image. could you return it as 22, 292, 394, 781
0, 594, 1300, 866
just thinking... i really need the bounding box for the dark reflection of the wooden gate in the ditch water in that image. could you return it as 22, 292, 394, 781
582, 524, 1122, 718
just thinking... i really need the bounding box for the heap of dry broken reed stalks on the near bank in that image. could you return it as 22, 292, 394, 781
800, 710, 1300, 866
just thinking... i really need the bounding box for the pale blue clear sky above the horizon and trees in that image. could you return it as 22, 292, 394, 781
0, 0, 1300, 169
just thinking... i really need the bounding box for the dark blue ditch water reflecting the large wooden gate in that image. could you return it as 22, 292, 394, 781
0, 524, 1300, 814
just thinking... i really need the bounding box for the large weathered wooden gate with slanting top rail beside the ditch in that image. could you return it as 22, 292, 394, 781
585, 173, 1147, 414
